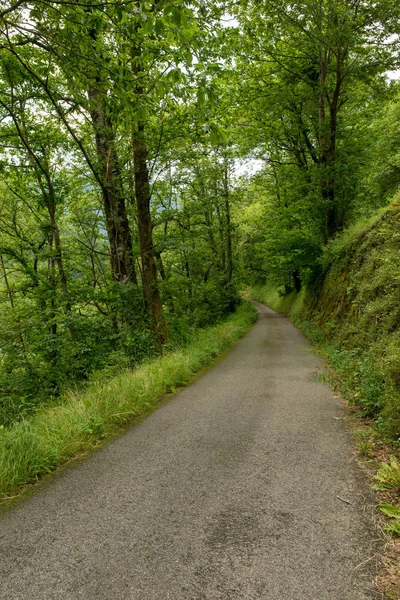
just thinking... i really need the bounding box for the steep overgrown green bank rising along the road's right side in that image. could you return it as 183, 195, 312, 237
249, 201, 400, 447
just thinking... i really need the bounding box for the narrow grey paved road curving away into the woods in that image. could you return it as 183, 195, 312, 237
0, 304, 377, 600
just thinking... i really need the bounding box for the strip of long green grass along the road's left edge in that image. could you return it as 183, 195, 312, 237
0, 303, 256, 500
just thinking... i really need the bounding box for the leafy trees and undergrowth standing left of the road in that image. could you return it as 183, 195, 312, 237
0, 0, 238, 426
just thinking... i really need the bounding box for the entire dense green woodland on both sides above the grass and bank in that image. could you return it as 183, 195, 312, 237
0, 0, 400, 427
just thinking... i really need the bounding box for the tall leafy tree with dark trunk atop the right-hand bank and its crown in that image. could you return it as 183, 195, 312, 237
234, 0, 395, 241
